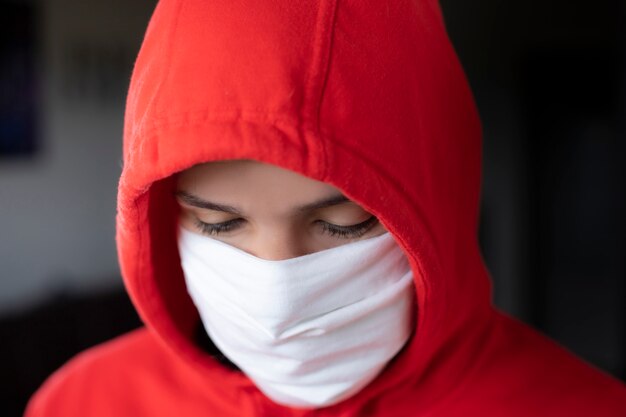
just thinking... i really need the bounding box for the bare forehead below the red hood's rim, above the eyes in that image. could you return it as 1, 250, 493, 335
177, 160, 341, 208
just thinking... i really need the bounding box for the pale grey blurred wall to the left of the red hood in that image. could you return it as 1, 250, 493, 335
0, 0, 155, 314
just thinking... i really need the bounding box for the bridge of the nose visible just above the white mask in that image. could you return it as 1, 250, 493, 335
246, 230, 309, 261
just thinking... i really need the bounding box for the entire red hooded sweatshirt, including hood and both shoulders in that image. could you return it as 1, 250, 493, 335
27, 0, 626, 417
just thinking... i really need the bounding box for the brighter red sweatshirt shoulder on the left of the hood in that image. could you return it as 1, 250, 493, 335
25, 328, 174, 417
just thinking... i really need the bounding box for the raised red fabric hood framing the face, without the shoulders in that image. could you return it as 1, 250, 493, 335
117, 0, 492, 408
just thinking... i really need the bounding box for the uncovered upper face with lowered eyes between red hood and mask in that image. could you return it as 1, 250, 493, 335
176, 160, 386, 260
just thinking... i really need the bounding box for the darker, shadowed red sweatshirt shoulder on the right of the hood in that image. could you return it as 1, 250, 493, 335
438, 313, 626, 417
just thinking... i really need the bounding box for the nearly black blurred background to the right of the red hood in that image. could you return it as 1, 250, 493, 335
441, 0, 626, 379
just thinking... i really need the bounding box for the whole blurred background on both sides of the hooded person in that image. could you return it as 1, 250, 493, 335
0, 0, 626, 416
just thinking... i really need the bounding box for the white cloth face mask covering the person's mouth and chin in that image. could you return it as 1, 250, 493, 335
178, 227, 414, 407
